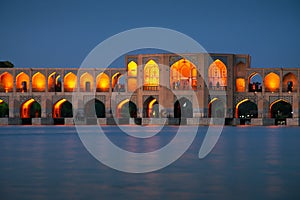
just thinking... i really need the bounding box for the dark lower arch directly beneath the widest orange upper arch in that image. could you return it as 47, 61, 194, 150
174, 97, 193, 118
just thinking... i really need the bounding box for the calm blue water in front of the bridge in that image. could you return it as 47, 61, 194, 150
0, 126, 300, 200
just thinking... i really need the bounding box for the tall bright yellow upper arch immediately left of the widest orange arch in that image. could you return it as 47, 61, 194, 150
144, 60, 159, 90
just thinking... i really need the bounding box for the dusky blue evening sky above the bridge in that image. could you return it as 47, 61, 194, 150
0, 0, 300, 68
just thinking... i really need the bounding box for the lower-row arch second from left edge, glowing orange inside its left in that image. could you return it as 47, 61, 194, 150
20, 99, 41, 118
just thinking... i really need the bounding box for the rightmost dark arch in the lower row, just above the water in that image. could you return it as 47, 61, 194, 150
269, 99, 293, 119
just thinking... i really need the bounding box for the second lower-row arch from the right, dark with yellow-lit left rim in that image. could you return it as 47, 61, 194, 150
235, 99, 258, 119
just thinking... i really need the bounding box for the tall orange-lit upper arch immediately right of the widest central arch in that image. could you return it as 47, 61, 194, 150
208, 59, 227, 90
